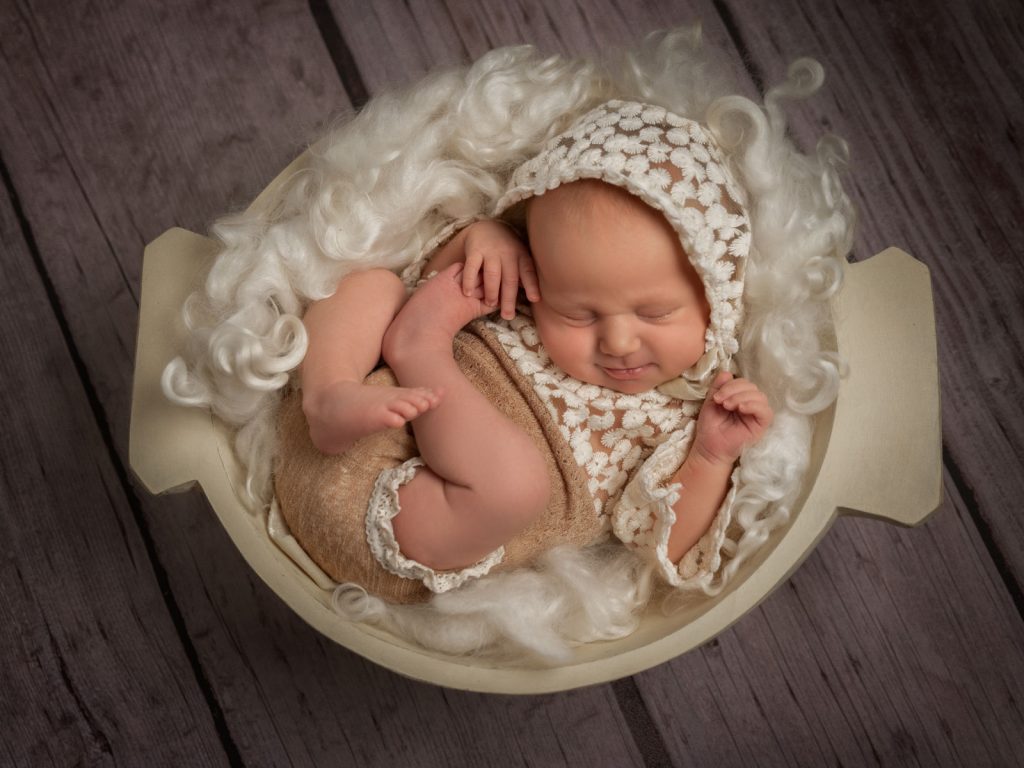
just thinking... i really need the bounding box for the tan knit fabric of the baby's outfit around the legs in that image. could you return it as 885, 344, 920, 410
274, 321, 601, 603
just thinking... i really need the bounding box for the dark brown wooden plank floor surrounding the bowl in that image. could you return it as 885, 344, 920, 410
0, 0, 1024, 767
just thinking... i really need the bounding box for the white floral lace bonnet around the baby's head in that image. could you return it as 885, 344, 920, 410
495, 100, 751, 399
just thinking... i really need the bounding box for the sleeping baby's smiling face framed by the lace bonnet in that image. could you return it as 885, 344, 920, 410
527, 180, 709, 394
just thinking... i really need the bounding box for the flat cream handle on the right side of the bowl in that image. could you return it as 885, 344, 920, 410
828, 248, 942, 525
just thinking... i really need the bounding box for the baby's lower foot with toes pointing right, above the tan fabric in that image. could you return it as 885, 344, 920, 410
306, 381, 441, 454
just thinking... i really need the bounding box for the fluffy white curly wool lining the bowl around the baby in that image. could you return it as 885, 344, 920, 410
163, 28, 854, 663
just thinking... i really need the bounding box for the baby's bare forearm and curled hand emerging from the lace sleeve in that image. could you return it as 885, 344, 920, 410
669, 373, 772, 562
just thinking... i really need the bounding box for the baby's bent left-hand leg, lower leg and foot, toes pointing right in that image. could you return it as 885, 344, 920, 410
301, 269, 439, 454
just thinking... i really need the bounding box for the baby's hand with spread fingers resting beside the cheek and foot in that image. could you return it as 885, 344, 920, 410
462, 220, 541, 319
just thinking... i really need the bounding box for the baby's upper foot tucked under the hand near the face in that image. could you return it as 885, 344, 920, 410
382, 263, 495, 368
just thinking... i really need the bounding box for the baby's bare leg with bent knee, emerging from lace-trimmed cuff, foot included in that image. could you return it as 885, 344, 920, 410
384, 264, 550, 570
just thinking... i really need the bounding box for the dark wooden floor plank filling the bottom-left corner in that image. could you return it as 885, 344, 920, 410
0, 163, 226, 766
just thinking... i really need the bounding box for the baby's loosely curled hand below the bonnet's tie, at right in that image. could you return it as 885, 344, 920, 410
691, 371, 773, 465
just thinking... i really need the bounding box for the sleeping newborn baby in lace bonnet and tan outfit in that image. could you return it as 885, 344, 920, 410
274, 101, 772, 602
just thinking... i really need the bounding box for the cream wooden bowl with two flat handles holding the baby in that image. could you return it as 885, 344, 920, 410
130, 158, 942, 693
